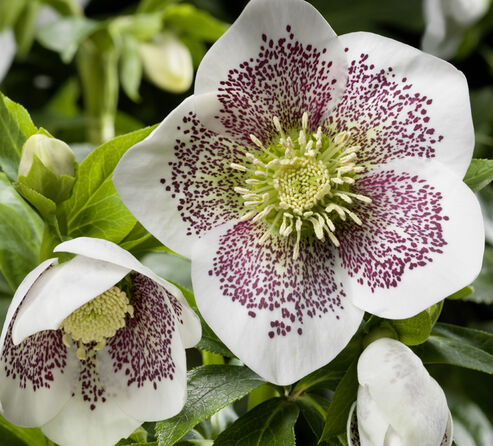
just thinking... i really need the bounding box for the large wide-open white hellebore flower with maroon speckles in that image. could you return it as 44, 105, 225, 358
113, 0, 484, 384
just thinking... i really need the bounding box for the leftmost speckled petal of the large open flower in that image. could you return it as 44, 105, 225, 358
113, 98, 244, 257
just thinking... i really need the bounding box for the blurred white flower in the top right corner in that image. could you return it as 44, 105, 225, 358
421, 0, 491, 59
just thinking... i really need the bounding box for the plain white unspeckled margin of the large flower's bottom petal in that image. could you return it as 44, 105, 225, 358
192, 220, 364, 385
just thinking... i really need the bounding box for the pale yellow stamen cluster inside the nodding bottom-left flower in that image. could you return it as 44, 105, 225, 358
60, 286, 134, 359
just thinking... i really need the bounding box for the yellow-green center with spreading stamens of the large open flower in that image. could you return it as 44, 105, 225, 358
231, 112, 371, 259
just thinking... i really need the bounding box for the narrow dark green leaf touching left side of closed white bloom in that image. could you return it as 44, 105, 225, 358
320, 358, 358, 440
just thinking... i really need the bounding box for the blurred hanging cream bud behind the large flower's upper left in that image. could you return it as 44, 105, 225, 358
140, 33, 193, 93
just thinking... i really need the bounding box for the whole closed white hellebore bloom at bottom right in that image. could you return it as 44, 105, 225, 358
348, 338, 452, 446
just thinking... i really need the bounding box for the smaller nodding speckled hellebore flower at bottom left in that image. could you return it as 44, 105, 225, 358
0, 238, 201, 446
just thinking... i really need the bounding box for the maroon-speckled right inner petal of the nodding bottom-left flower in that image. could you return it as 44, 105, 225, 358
98, 274, 187, 421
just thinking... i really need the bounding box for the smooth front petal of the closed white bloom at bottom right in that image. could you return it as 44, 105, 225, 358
358, 338, 449, 446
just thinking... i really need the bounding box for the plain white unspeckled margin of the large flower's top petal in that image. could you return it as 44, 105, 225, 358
194, 0, 347, 138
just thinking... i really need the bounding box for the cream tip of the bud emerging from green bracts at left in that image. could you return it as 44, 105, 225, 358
19, 135, 75, 177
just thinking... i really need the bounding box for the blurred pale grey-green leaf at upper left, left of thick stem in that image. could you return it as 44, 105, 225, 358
38, 17, 100, 63
